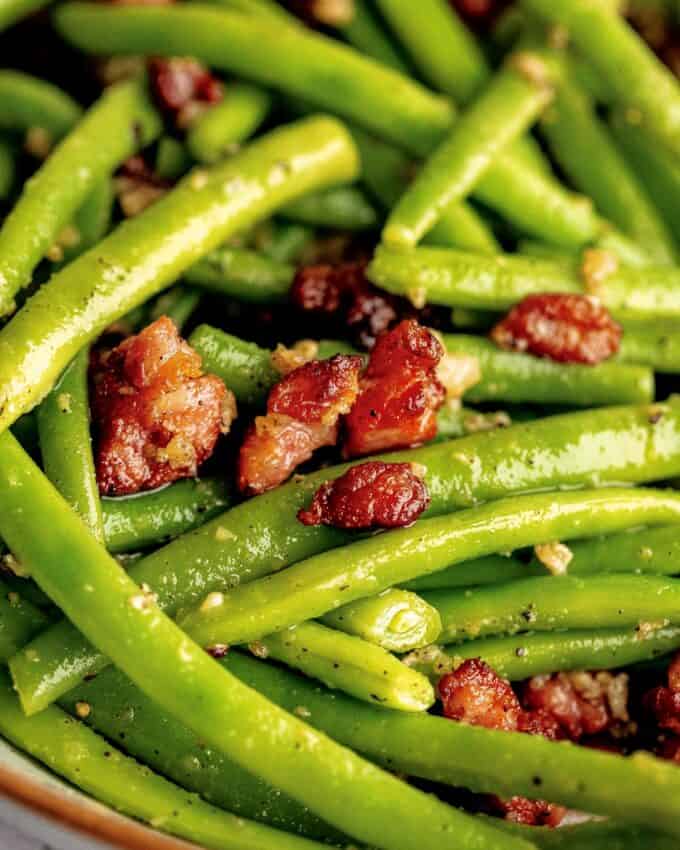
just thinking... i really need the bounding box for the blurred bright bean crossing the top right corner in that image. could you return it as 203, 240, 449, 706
524, 0, 680, 157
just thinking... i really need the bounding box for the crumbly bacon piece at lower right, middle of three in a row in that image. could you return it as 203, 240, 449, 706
523, 672, 628, 741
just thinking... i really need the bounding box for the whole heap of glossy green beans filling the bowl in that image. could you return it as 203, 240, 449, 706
0, 0, 680, 850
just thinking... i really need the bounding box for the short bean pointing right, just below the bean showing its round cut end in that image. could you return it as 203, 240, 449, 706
253, 622, 435, 711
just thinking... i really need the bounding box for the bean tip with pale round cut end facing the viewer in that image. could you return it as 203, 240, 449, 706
321, 588, 441, 652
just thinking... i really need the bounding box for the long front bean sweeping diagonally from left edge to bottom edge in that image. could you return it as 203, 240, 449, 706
0, 433, 531, 850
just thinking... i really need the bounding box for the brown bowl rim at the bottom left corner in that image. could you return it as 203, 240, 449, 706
0, 764, 198, 850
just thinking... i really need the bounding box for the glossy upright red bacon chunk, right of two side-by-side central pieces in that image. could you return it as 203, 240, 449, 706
344, 319, 446, 457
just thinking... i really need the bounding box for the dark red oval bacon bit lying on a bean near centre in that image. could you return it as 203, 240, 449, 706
298, 461, 430, 528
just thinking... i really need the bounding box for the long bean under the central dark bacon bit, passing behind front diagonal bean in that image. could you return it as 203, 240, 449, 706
17, 404, 680, 710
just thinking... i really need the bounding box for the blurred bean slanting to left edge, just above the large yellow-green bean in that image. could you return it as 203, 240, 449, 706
0, 77, 161, 313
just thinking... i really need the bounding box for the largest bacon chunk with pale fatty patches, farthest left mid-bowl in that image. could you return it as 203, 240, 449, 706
92, 316, 235, 495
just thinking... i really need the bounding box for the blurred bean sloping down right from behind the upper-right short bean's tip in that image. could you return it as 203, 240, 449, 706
541, 61, 675, 265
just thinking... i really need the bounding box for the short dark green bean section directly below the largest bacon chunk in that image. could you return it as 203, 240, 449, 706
102, 478, 230, 554
